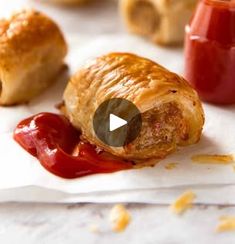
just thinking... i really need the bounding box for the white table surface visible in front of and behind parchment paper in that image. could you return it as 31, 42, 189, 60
0, 0, 235, 244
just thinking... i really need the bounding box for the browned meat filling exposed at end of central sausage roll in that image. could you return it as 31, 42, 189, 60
128, 102, 188, 158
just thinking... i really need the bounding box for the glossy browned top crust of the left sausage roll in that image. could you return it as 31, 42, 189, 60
0, 9, 67, 55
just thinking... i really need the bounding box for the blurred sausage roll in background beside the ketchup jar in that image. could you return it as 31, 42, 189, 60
120, 0, 197, 45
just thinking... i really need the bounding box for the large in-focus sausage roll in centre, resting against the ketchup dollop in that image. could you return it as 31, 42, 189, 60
64, 53, 204, 161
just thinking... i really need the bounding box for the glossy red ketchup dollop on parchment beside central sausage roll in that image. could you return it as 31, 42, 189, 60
14, 113, 132, 179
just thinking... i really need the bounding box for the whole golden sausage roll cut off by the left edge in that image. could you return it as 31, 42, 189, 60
0, 10, 67, 105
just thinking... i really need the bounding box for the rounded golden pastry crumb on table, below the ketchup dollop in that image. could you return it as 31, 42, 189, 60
110, 204, 131, 232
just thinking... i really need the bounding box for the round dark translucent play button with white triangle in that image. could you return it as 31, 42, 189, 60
93, 98, 142, 147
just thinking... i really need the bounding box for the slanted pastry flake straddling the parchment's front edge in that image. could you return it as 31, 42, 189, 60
170, 191, 196, 214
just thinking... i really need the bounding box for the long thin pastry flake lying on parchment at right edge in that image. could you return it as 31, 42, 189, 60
191, 154, 235, 164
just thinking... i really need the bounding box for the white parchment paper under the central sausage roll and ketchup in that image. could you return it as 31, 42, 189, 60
0, 35, 235, 203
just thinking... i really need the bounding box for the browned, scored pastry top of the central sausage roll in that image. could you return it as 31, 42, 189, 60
65, 53, 198, 112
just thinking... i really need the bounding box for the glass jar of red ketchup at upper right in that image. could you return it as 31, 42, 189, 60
185, 0, 235, 104
